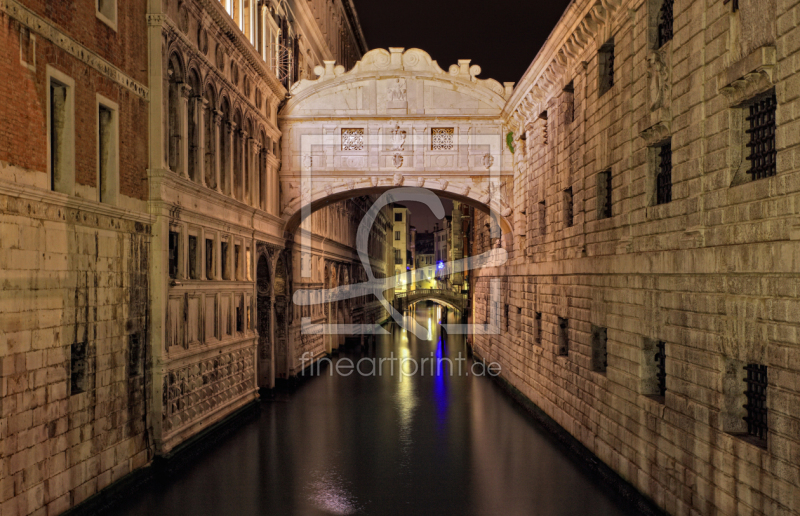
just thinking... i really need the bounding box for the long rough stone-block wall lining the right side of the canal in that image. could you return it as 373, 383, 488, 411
473, 0, 800, 514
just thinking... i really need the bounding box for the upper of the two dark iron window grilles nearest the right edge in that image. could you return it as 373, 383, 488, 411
747, 92, 778, 180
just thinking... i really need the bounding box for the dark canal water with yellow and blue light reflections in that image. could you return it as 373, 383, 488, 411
106, 306, 630, 516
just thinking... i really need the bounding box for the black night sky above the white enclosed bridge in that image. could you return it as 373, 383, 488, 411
353, 0, 570, 83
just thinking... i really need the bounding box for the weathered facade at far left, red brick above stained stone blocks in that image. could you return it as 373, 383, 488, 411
0, 0, 152, 515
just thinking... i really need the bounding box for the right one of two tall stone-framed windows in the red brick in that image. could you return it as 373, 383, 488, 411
97, 95, 119, 205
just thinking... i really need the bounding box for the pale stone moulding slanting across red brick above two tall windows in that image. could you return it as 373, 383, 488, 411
0, 0, 150, 100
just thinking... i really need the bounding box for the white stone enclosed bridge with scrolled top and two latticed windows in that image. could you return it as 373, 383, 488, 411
280, 48, 513, 233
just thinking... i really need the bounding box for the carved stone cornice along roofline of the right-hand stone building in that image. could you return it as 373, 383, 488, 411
503, 0, 627, 131
